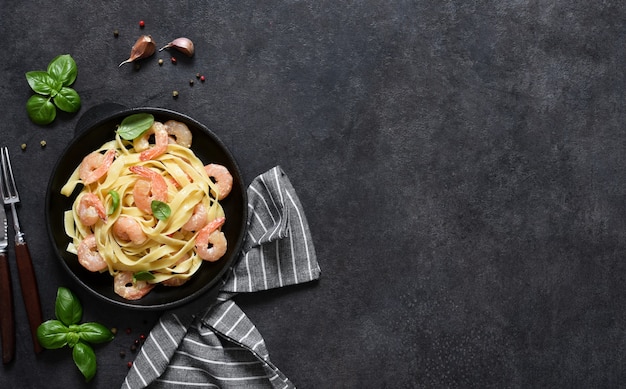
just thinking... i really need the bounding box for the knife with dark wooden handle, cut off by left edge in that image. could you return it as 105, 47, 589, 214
0, 199, 15, 364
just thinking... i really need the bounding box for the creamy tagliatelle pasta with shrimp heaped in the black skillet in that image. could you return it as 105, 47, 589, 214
61, 118, 226, 300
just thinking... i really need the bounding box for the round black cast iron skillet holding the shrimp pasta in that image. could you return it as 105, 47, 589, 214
46, 105, 247, 310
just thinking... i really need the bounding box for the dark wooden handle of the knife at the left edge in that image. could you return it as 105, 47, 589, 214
0, 253, 15, 364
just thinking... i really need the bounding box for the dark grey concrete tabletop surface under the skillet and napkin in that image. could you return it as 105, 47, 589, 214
0, 0, 626, 388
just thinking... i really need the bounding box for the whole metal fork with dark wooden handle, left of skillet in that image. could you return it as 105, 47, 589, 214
0, 147, 43, 353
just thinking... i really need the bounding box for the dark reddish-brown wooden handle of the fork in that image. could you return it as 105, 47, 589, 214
15, 242, 43, 354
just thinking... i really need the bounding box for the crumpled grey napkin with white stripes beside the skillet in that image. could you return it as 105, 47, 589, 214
122, 166, 320, 389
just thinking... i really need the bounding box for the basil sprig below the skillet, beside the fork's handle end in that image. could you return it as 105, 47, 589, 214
37, 287, 114, 382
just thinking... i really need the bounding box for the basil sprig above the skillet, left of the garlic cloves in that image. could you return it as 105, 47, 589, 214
26, 54, 80, 125
